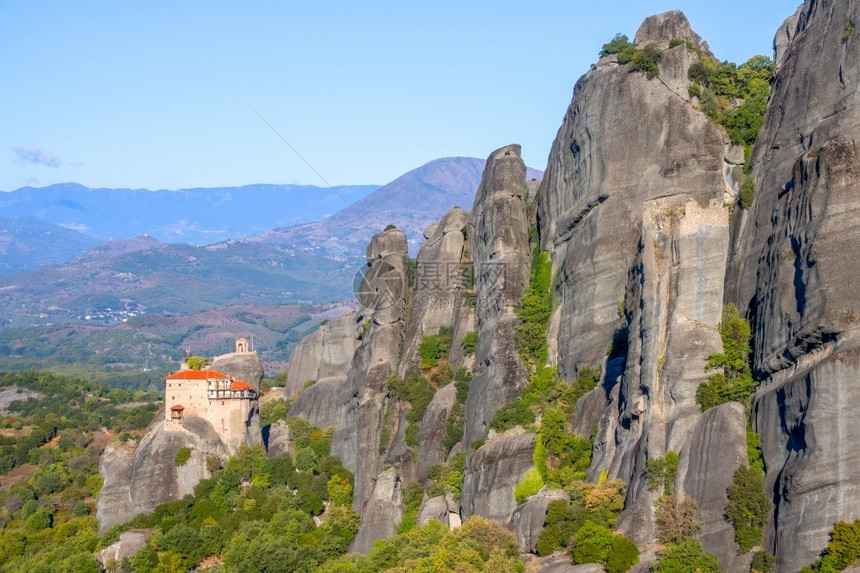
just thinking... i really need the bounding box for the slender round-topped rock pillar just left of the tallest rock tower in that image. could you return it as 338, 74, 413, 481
463, 145, 530, 446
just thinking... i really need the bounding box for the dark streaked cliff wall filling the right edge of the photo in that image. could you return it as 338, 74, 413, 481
727, 1, 860, 571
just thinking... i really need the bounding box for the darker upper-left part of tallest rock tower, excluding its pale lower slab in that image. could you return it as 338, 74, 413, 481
537, 12, 728, 378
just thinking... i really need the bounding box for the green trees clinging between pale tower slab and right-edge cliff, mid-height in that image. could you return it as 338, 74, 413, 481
696, 304, 758, 410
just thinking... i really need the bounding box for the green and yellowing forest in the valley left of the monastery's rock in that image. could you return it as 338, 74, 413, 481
0, 372, 161, 573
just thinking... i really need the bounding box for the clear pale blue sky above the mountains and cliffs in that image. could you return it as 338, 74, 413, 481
0, 0, 799, 191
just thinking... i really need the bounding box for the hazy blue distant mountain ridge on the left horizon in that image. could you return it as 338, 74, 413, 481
0, 183, 379, 245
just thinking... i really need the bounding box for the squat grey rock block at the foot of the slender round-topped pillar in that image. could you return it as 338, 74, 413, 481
460, 434, 535, 523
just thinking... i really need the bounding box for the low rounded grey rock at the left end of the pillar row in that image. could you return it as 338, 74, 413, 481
286, 312, 359, 398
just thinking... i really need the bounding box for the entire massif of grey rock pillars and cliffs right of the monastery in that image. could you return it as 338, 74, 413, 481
278, 0, 860, 572
